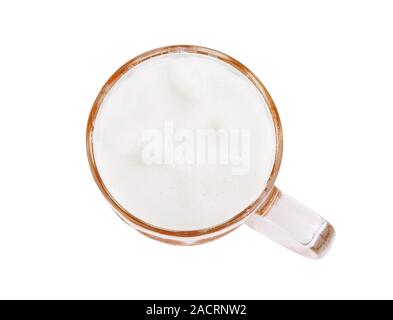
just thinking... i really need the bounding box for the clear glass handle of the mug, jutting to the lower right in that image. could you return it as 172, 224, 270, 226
246, 187, 335, 259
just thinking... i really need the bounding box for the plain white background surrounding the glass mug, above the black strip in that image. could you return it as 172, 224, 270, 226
0, 0, 393, 299
